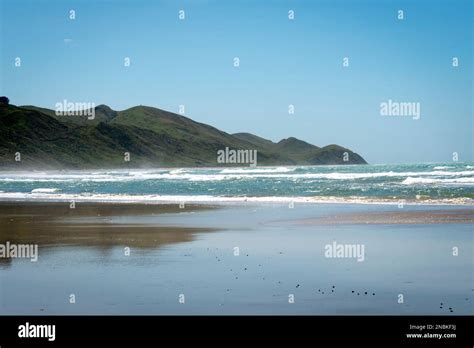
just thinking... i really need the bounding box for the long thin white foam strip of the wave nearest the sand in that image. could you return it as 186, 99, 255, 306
0, 192, 474, 205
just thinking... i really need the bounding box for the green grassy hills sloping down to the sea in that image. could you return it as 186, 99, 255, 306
0, 104, 366, 169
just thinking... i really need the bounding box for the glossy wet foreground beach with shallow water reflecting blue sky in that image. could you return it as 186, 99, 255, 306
0, 204, 473, 315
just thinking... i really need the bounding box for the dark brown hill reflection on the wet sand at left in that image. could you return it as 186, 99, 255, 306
0, 202, 216, 265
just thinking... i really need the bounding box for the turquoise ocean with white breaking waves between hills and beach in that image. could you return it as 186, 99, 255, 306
0, 163, 474, 205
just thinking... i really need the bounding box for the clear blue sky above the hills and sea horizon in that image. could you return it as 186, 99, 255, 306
0, 0, 474, 163
